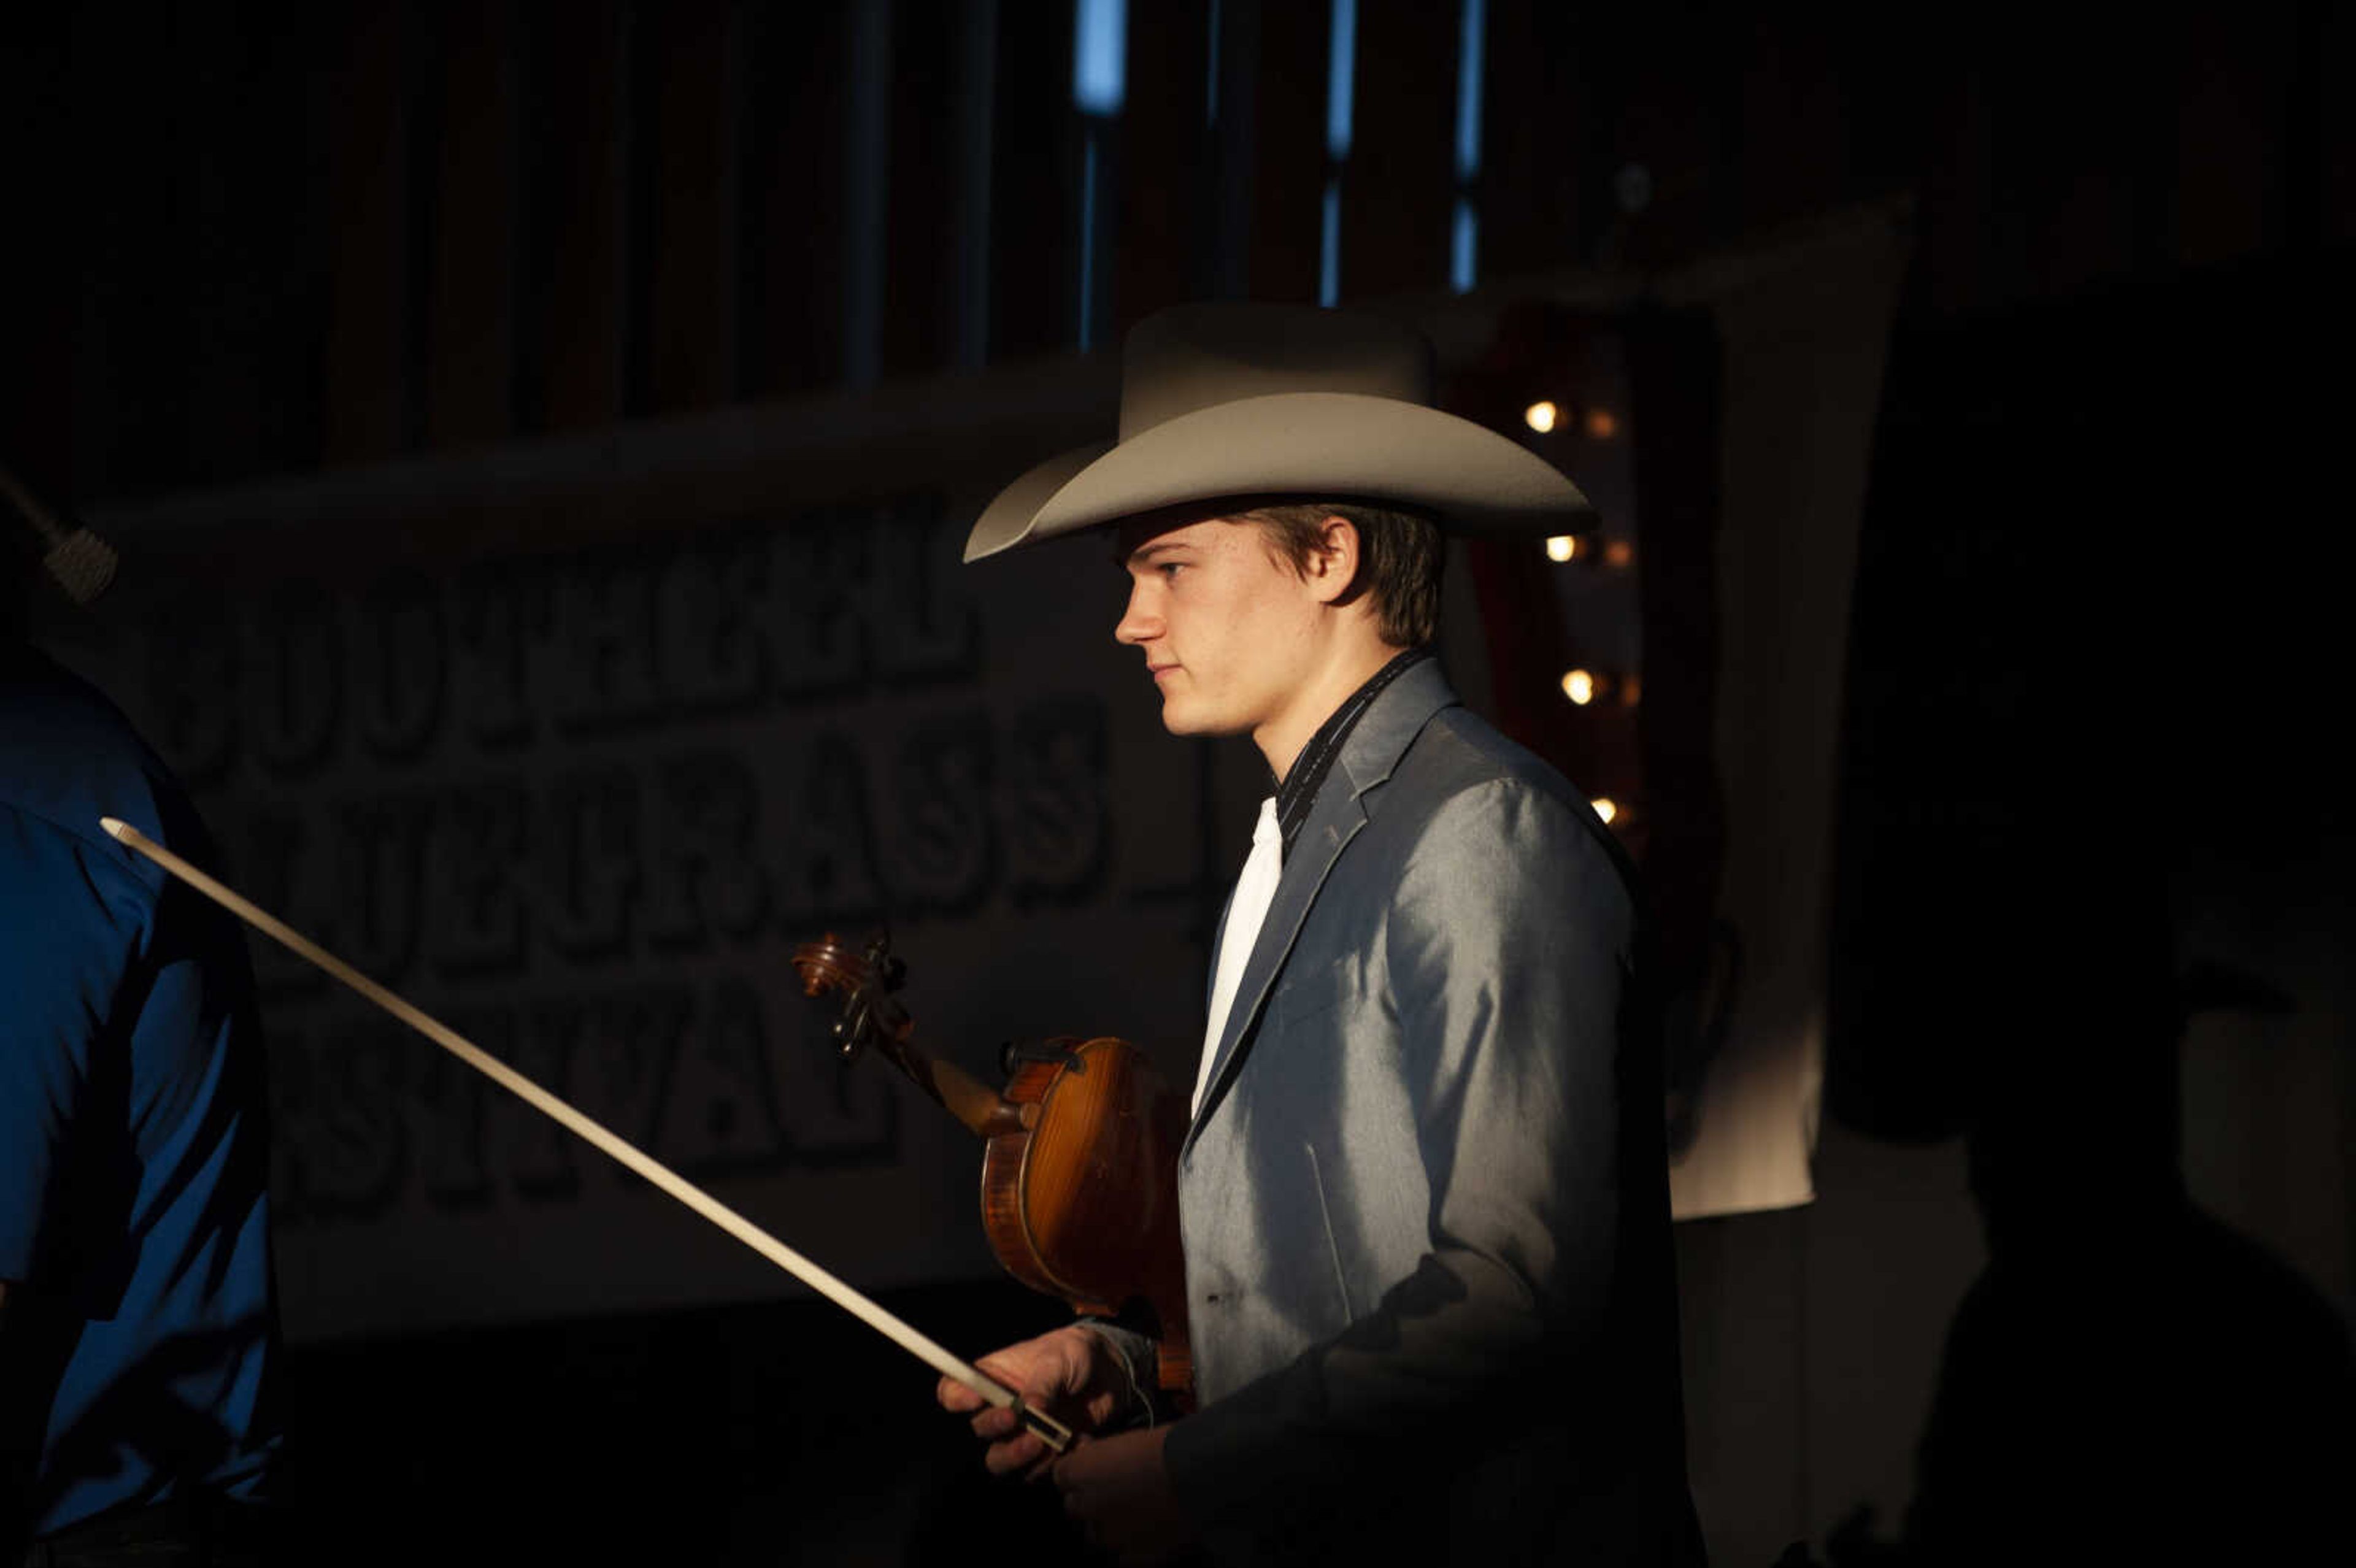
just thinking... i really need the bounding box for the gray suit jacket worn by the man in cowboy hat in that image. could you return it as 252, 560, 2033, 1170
1166, 664, 1699, 1563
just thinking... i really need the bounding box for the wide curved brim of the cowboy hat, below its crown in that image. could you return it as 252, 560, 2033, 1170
966, 391, 1595, 560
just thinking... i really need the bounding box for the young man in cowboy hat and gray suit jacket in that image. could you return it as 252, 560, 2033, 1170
940, 306, 1699, 1563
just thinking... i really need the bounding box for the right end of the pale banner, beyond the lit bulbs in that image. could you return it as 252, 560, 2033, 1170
1671, 212, 1908, 1220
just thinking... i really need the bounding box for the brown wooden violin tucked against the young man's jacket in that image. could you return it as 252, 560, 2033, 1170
791, 932, 1195, 1405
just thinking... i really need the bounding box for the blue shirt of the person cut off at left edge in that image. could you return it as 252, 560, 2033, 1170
0, 638, 278, 1542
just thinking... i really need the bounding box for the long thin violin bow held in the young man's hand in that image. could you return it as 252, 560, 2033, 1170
99, 817, 1072, 1453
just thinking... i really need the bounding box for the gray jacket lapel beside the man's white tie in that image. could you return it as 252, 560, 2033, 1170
1180, 659, 1456, 1154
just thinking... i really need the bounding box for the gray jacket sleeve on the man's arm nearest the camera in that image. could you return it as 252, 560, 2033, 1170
1166, 779, 1657, 1526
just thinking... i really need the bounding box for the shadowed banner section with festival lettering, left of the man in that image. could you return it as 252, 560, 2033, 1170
61, 374, 1251, 1337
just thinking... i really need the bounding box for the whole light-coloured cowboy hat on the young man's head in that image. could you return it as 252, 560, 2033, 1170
966, 304, 1595, 560
